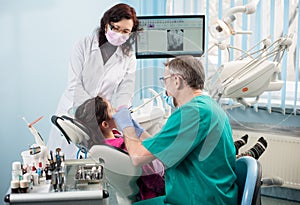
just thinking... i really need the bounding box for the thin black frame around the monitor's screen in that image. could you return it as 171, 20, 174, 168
135, 14, 205, 59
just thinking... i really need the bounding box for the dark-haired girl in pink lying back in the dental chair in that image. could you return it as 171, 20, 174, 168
75, 96, 165, 200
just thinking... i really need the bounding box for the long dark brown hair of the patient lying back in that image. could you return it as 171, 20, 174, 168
75, 96, 109, 148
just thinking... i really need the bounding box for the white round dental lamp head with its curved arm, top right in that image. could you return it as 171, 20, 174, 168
209, 0, 259, 42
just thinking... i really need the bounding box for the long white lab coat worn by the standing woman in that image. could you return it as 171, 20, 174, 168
47, 34, 136, 158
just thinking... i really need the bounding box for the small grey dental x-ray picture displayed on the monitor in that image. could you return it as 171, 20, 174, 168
167, 29, 184, 51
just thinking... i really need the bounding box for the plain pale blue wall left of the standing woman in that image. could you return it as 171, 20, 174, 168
0, 0, 121, 199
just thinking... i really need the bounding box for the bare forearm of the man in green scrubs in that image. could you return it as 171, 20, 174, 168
123, 127, 155, 166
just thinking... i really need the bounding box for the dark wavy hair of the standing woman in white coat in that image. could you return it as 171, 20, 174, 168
98, 3, 141, 55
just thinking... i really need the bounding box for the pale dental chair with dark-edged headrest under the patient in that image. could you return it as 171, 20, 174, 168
51, 115, 142, 205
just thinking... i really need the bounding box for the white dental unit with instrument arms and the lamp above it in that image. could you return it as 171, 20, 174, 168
205, 0, 293, 108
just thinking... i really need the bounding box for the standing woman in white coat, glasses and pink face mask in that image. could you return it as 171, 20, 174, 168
48, 3, 139, 158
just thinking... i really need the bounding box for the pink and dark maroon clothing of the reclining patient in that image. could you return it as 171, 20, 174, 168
105, 130, 165, 200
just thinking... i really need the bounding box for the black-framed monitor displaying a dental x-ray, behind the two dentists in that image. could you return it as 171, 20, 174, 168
135, 15, 205, 58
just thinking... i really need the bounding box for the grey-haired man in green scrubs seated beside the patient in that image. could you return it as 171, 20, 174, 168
113, 56, 238, 205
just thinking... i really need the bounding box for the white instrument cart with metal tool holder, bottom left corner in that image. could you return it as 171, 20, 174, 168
4, 160, 109, 205
